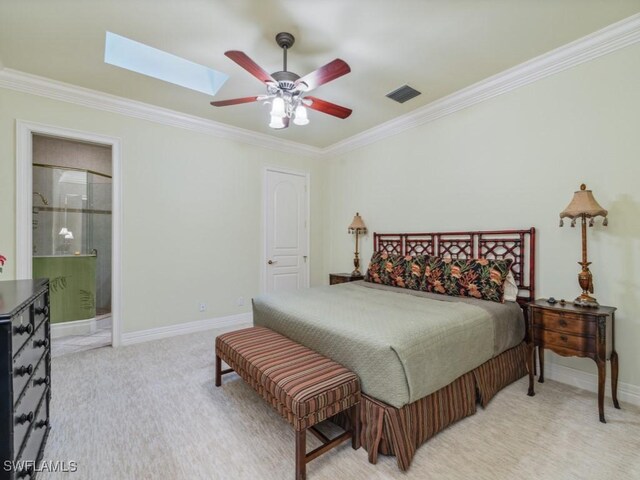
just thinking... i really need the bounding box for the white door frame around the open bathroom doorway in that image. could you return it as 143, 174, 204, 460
16, 120, 122, 347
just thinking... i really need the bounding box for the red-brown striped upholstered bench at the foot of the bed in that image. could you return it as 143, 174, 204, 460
216, 327, 360, 480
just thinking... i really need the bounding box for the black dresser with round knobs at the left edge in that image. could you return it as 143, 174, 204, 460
0, 279, 51, 480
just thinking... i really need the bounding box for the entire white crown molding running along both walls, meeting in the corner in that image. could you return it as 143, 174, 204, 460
0, 13, 640, 158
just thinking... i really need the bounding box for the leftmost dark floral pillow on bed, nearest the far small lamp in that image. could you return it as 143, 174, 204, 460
365, 252, 426, 290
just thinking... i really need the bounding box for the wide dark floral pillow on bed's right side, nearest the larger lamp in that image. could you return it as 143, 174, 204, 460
421, 256, 513, 303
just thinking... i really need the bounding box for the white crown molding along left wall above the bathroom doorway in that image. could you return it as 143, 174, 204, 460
0, 68, 322, 157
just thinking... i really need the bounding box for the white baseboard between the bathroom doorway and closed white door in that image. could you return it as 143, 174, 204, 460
121, 312, 253, 345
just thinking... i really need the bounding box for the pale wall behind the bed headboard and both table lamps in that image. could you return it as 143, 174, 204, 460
324, 45, 640, 386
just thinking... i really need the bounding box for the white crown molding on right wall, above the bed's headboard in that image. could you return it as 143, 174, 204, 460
322, 14, 640, 156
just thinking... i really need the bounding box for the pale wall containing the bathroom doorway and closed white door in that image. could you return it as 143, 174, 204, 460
0, 89, 323, 332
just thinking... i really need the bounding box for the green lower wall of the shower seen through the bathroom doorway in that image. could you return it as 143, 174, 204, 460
33, 255, 96, 323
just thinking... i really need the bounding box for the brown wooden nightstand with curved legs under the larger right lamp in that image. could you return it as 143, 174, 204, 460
527, 300, 620, 423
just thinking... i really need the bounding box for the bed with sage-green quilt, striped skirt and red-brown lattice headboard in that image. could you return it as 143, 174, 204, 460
253, 228, 535, 470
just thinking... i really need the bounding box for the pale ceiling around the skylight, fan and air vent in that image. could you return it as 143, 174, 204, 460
0, 0, 640, 147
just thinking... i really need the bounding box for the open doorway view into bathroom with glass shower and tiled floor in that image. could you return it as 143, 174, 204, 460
31, 134, 113, 356
